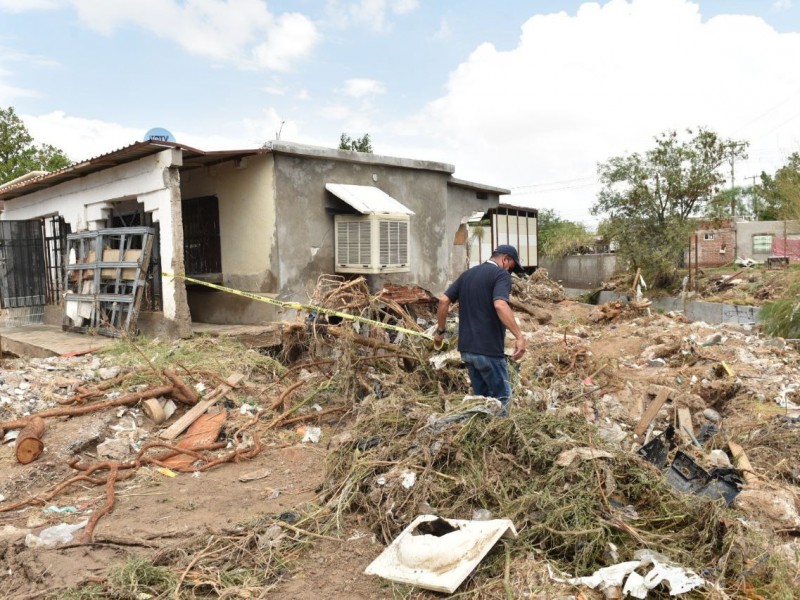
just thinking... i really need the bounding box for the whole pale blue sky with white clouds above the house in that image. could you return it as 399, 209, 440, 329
0, 0, 800, 225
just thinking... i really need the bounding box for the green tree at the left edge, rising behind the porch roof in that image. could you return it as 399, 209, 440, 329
0, 107, 72, 184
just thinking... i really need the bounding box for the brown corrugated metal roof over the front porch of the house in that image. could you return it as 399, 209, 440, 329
0, 141, 269, 200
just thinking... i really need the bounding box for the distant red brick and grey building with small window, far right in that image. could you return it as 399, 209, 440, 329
687, 219, 800, 267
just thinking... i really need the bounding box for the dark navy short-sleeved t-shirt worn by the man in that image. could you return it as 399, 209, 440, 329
444, 261, 511, 357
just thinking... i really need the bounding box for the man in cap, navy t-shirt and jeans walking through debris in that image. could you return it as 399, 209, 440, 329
434, 244, 527, 416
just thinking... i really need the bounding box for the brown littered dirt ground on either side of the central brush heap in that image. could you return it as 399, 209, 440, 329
0, 272, 800, 600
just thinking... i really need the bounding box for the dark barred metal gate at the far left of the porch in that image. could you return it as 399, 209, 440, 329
0, 220, 47, 308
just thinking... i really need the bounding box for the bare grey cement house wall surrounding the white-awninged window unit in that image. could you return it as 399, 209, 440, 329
272, 148, 497, 300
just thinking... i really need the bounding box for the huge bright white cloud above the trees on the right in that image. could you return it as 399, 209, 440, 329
394, 0, 800, 225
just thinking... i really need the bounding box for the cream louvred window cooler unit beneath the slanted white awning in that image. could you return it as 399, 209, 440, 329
335, 214, 410, 274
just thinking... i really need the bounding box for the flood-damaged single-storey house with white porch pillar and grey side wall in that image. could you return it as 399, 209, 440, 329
0, 140, 509, 335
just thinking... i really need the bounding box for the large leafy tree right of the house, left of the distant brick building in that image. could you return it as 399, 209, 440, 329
592, 128, 747, 287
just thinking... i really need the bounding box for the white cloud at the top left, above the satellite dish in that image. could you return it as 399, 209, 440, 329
65, 0, 320, 71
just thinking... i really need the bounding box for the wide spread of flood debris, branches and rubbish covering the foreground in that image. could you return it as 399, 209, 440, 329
0, 271, 800, 599
